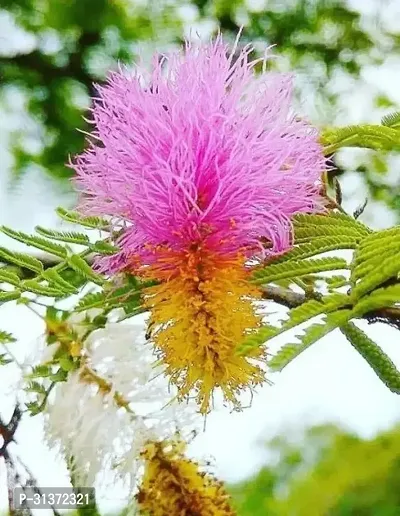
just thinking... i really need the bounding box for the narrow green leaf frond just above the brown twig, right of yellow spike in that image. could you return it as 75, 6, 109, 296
251, 257, 348, 285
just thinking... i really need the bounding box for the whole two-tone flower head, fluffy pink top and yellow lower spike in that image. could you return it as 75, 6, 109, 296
73, 37, 325, 412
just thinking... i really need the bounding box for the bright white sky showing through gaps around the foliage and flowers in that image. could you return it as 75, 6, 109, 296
0, 0, 400, 516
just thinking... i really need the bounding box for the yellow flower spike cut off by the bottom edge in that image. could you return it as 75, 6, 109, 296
136, 441, 235, 516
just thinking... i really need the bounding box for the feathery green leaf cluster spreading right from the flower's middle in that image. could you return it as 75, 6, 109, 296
238, 213, 400, 378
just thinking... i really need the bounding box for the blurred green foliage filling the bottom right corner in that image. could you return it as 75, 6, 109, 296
231, 425, 400, 516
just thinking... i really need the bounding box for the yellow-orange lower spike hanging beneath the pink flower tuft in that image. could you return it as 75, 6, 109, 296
138, 246, 264, 414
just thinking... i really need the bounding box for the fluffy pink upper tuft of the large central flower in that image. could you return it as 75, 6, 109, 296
72, 37, 326, 270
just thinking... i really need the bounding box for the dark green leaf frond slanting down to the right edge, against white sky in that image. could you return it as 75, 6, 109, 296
341, 322, 400, 394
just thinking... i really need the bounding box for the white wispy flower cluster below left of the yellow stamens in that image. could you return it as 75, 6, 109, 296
45, 316, 201, 489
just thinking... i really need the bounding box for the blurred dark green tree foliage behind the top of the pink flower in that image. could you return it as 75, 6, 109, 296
0, 0, 400, 217
